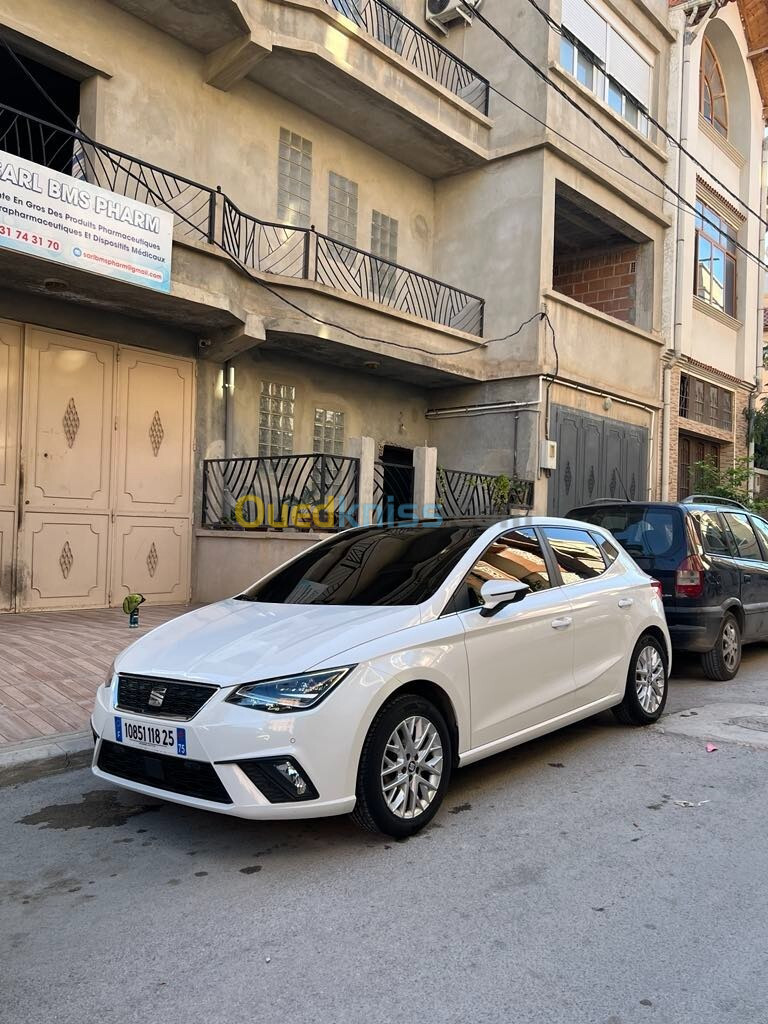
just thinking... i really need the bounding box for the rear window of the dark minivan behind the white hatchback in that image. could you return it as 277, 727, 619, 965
570, 505, 685, 558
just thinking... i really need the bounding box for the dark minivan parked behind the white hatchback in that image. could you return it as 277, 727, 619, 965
568, 495, 768, 680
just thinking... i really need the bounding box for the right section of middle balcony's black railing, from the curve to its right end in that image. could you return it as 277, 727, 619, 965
222, 199, 485, 336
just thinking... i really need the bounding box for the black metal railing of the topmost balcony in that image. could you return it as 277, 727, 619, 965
326, 0, 490, 114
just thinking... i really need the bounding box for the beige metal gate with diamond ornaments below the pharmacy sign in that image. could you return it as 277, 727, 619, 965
0, 327, 195, 609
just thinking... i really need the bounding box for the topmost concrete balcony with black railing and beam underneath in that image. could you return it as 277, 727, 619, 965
105, 0, 492, 178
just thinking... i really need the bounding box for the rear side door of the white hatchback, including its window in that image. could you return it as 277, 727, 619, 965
542, 526, 630, 708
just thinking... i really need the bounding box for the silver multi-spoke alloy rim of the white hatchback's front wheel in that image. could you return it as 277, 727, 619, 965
381, 715, 442, 818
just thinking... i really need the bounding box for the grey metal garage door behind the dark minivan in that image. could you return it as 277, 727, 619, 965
548, 406, 648, 515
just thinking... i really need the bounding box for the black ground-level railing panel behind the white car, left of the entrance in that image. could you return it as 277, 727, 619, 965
202, 455, 359, 529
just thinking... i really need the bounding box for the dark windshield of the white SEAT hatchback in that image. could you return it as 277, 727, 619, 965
238, 523, 486, 605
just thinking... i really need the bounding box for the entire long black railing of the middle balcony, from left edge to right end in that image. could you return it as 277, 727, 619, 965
0, 103, 484, 337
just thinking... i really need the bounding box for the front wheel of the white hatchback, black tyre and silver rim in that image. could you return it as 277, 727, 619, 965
352, 693, 453, 839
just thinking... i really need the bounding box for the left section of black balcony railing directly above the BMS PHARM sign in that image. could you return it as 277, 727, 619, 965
0, 103, 216, 241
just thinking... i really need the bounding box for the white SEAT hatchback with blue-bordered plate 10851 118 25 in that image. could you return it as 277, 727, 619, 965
92, 516, 671, 837
